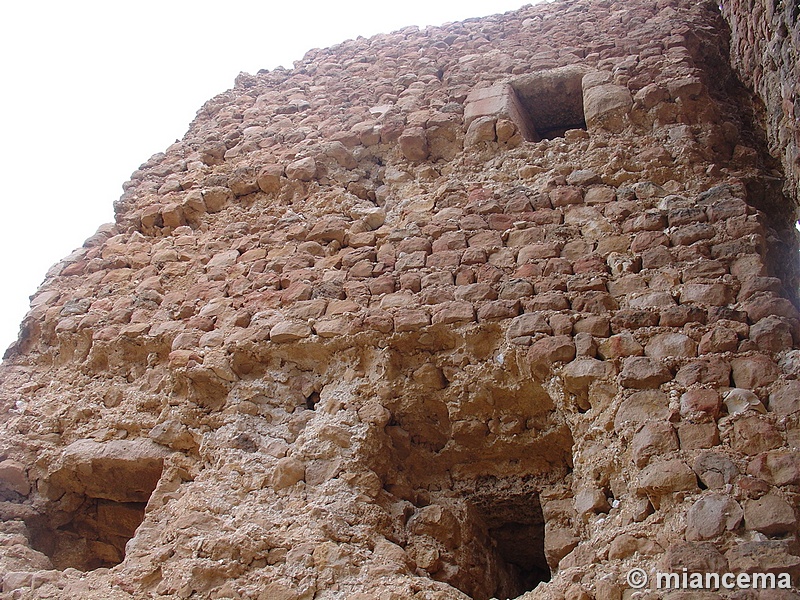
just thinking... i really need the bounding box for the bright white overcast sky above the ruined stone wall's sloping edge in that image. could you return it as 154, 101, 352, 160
0, 0, 531, 354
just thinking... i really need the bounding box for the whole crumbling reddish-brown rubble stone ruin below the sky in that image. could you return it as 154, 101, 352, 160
0, 0, 800, 600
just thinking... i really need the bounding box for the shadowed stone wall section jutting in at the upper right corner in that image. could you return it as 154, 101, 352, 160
720, 0, 800, 205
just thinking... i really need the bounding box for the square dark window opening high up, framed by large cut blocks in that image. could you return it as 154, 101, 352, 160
511, 66, 586, 141
